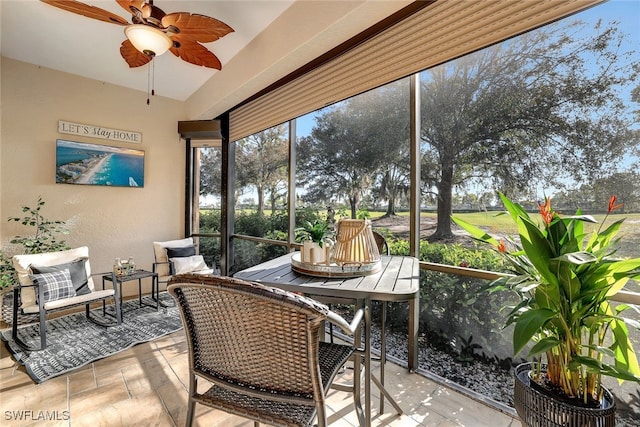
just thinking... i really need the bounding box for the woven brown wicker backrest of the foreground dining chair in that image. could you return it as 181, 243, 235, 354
168, 275, 327, 405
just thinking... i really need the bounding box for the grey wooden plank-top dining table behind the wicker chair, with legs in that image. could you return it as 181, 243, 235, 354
233, 252, 420, 426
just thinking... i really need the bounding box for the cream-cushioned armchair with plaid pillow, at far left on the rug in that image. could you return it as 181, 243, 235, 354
11, 246, 122, 351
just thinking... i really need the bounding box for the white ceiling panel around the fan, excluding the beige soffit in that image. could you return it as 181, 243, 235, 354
1, 0, 292, 100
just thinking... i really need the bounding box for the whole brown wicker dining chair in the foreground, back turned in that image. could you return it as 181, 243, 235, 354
167, 275, 364, 427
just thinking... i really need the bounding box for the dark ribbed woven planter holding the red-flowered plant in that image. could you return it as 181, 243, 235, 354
514, 363, 616, 427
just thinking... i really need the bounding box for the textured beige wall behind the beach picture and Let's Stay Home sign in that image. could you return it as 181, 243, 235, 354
0, 58, 186, 295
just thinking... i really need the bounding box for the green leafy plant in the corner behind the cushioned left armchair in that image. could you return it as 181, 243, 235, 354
0, 197, 69, 290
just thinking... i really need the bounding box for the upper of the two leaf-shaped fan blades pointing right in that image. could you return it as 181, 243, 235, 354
162, 12, 233, 43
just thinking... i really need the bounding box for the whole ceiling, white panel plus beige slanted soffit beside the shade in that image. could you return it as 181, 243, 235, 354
0, 0, 410, 118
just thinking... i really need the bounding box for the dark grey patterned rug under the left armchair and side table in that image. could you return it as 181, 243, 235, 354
0, 293, 182, 383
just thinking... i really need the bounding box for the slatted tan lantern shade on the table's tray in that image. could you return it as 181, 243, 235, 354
333, 219, 380, 265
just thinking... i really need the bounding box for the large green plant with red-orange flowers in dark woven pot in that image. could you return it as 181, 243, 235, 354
453, 194, 640, 426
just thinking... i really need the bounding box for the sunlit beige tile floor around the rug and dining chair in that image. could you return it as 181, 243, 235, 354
0, 324, 521, 427
